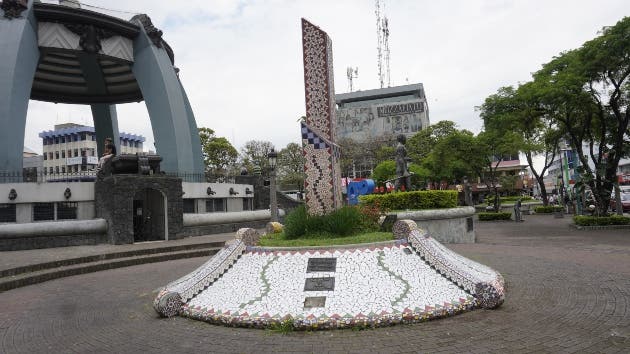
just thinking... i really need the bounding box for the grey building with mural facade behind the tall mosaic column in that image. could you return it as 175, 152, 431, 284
335, 84, 430, 143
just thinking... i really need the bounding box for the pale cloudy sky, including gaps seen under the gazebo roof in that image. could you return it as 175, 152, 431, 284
24, 0, 630, 152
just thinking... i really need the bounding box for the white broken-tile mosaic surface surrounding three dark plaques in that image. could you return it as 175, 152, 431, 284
187, 245, 470, 319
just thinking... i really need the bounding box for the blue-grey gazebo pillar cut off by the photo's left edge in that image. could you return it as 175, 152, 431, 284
0, 1, 39, 172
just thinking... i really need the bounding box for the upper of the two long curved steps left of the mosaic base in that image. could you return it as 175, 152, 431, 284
0, 241, 225, 279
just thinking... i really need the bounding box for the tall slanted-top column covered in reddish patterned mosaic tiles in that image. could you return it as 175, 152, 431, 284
301, 19, 342, 215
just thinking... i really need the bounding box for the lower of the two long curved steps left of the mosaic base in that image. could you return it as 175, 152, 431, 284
0, 242, 223, 292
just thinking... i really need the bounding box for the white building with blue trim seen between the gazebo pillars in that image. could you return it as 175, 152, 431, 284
39, 123, 145, 175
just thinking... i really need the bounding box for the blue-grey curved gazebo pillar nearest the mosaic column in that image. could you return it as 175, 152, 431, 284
132, 16, 203, 173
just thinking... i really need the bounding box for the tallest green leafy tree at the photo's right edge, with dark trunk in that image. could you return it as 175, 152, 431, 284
534, 17, 630, 215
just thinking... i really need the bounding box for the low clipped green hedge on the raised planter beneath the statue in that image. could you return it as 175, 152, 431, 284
359, 190, 457, 210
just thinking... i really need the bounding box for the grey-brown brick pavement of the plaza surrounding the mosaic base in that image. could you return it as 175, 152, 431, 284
0, 215, 630, 353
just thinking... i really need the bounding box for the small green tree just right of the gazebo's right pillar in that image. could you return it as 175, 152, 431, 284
199, 128, 238, 174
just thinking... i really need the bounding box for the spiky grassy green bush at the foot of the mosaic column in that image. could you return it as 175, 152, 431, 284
284, 205, 382, 239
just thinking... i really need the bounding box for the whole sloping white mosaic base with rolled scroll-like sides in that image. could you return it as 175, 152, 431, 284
154, 220, 505, 330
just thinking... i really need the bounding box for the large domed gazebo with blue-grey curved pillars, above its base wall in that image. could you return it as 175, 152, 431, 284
0, 0, 204, 173
